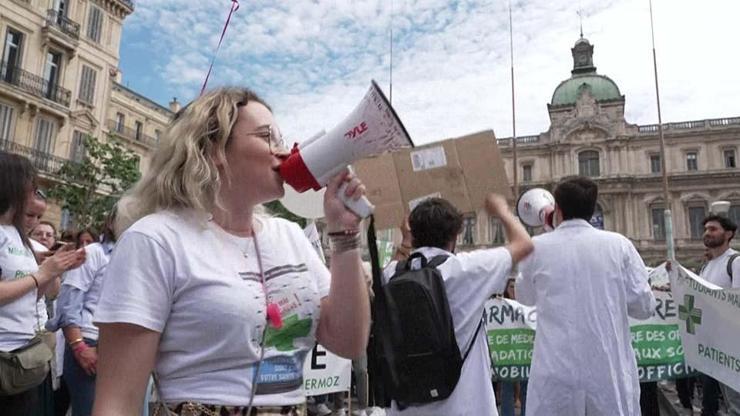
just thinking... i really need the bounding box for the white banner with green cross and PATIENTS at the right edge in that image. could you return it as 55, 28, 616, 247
670, 265, 740, 391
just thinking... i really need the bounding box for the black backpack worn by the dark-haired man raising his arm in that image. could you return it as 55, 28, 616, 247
374, 253, 483, 409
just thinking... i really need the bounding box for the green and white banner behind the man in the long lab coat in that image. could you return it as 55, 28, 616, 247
484, 266, 690, 382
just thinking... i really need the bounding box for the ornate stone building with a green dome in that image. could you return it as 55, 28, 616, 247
494, 38, 740, 265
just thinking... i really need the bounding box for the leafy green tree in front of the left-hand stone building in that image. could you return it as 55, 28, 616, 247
49, 136, 140, 229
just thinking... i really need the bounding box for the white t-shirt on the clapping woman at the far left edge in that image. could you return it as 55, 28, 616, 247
0, 225, 40, 352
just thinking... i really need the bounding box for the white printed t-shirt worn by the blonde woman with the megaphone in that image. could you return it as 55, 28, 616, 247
95, 211, 330, 406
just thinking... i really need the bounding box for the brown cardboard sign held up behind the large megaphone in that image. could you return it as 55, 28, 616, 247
354, 130, 512, 230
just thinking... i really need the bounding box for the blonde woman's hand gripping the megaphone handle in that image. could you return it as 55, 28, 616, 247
324, 170, 365, 232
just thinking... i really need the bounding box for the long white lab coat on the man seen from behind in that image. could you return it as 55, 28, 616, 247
516, 219, 655, 416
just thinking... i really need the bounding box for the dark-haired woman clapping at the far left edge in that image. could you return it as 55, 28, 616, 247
0, 151, 85, 415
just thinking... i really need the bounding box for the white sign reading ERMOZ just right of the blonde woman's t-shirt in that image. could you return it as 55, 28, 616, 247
303, 344, 352, 396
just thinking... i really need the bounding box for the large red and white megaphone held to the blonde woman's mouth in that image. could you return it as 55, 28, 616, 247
280, 81, 414, 218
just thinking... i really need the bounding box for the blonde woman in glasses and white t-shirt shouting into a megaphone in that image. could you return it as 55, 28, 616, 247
93, 88, 369, 416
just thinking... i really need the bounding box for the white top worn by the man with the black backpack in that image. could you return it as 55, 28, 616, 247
383, 247, 512, 416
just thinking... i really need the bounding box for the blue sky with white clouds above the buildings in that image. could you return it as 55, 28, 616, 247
120, 0, 740, 144
